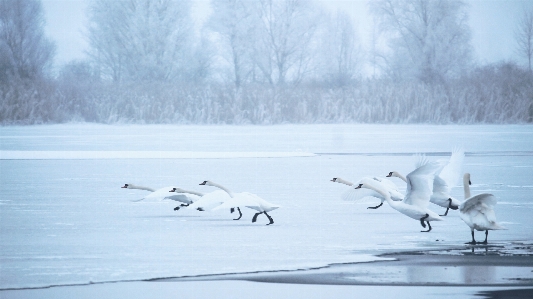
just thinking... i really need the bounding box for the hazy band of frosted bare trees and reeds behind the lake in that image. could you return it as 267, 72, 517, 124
0, 0, 533, 125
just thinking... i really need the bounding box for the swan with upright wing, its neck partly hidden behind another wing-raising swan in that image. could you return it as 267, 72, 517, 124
387, 150, 465, 216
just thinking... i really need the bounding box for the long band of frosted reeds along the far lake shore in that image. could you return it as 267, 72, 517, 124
0, 64, 533, 125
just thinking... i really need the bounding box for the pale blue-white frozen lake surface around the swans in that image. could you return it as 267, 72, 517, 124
0, 124, 533, 289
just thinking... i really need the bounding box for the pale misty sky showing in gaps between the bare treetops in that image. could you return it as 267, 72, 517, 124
42, 0, 533, 72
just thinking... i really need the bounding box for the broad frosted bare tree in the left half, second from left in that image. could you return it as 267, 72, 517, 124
88, 0, 192, 81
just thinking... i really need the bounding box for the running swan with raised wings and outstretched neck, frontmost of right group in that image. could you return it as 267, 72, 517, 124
357, 161, 443, 232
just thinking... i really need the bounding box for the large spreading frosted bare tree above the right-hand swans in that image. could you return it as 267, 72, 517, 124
370, 0, 471, 82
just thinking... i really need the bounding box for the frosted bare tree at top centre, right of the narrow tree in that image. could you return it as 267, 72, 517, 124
249, 0, 320, 85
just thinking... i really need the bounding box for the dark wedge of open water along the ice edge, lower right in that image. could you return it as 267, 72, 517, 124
157, 242, 533, 291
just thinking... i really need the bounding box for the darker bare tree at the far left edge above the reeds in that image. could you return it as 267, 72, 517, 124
0, 0, 55, 79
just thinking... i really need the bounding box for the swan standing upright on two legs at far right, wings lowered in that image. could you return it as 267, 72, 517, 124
459, 173, 506, 244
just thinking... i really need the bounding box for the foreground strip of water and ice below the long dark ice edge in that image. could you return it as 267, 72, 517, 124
0, 242, 533, 299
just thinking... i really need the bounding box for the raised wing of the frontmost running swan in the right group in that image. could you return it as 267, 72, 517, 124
403, 160, 442, 208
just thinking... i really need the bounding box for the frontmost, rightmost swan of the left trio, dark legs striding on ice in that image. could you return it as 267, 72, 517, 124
200, 181, 279, 225
